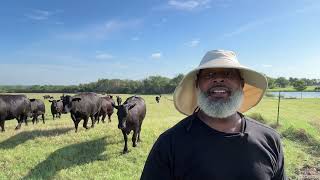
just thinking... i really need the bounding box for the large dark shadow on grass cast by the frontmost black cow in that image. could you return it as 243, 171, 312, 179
23, 137, 112, 179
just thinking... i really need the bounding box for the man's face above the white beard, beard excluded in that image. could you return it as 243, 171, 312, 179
198, 69, 243, 100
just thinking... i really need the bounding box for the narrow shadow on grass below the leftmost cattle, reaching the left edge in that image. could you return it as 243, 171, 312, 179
0, 128, 73, 149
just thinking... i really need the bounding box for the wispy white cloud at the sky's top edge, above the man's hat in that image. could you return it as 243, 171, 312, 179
168, 0, 210, 10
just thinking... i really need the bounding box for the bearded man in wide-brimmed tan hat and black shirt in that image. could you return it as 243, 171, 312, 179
141, 50, 286, 180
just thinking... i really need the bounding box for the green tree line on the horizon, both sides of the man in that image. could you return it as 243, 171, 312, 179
0, 74, 320, 94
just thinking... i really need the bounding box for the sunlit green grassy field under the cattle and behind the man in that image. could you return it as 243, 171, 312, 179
0, 94, 320, 180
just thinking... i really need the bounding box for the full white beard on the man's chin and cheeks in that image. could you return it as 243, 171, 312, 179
197, 89, 243, 118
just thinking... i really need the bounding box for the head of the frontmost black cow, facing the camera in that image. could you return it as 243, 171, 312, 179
112, 103, 136, 129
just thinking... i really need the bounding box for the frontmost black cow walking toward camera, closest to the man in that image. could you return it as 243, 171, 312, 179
113, 96, 146, 153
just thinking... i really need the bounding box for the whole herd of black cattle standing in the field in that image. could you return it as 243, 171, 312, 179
0, 93, 161, 153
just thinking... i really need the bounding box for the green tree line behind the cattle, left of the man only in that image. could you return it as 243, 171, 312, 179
0, 74, 184, 94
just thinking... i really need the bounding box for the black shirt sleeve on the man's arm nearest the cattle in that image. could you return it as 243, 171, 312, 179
140, 134, 174, 180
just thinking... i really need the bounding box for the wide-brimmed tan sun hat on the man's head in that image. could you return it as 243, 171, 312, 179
173, 50, 268, 115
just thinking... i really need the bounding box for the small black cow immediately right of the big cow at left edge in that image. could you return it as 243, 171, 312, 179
30, 99, 46, 124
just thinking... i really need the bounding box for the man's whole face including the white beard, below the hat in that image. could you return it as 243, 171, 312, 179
197, 69, 244, 118
